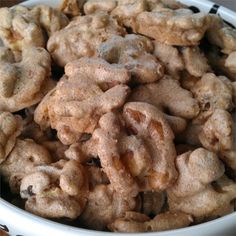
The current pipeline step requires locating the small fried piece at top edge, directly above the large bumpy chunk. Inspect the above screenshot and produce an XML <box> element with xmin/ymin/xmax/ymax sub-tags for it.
<box><xmin>84</xmin><ymin>0</ymin><xmax>117</xmax><ymax>15</ymax></box>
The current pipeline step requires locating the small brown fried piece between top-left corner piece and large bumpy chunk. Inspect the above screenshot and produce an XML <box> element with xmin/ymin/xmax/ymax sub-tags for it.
<box><xmin>31</xmin><ymin>5</ymin><xmax>69</xmax><ymax>36</ymax></box>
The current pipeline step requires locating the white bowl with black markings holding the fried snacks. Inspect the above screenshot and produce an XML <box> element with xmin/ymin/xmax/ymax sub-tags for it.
<box><xmin>0</xmin><ymin>0</ymin><xmax>236</xmax><ymax>236</ymax></box>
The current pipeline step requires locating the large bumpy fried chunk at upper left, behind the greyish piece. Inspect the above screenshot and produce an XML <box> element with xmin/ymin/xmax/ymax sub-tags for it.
<box><xmin>47</xmin><ymin>13</ymin><xmax>126</xmax><ymax>66</ymax></box>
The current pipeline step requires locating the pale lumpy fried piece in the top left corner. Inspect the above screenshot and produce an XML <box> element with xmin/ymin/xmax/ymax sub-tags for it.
<box><xmin>0</xmin><ymin>6</ymin><xmax>45</xmax><ymax>51</ymax></box>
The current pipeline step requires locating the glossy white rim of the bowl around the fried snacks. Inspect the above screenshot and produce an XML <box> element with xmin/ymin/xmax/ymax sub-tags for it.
<box><xmin>0</xmin><ymin>0</ymin><xmax>236</xmax><ymax>236</ymax></box>
